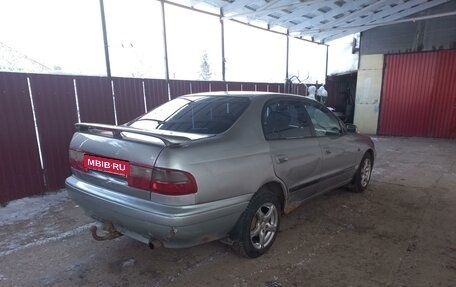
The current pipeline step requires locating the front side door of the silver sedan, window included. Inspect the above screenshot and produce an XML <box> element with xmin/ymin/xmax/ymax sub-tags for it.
<box><xmin>305</xmin><ymin>101</ymin><xmax>359</xmax><ymax>192</ymax></box>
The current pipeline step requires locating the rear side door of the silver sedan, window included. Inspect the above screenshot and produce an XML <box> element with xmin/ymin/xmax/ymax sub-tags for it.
<box><xmin>262</xmin><ymin>99</ymin><xmax>322</xmax><ymax>201</ymax></box>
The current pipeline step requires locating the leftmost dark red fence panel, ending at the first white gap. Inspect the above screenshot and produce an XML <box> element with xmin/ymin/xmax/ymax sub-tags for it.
<box><xmin>0</xmin><ymin>73</ymin><xmax>44</xmax><ymax>202</ymax></box>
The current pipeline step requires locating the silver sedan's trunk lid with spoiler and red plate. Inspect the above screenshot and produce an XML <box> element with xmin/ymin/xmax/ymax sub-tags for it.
<box><xmin>70</xmin><ymin>123</ymin><xmax>207</xmax><ymax>200</ymax></box>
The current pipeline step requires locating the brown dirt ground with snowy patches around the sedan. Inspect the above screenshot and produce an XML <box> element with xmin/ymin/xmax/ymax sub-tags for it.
<box><xmin>0</xmin><ymin>137</ymin><xmax>456</xmax><ymax>287</ymax></box>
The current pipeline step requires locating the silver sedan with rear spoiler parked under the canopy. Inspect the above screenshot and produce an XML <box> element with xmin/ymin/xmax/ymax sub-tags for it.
<box><xmin>66</xmin><ymin>92</ymin><xmax>375</xmax><ymax>258</ymax></box>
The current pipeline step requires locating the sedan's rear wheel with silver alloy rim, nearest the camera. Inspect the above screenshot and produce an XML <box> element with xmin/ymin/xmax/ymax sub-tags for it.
<box><xmin>231</xmin><ymin>188</ymin><xmax>281</xmax><ymax>258</ymax></box>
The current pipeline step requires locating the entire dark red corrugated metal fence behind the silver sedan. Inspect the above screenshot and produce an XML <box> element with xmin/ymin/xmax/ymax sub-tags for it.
<box><xmin>0</xmin><ymin>72</ymin><xmax>306</xmax><ymax>202</ymax></box>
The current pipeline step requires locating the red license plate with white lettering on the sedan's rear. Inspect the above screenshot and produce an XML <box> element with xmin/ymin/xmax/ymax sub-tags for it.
<box><xmin>84</xmin><ymin>154</ymin><xmax>130</xmax><ymax>176</ymax></box>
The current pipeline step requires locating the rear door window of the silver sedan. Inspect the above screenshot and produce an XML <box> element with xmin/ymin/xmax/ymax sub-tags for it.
<box><xmin>262</xmin><ymin>100</ymin><xmax>312</xmax><ymax>140</ymax></box>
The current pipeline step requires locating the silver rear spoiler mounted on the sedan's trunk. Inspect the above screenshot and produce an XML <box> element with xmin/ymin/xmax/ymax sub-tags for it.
<box><xmin>75</xmin><ymin>123</ymin><xmax>190</xmax><ymax>146</ymax></box>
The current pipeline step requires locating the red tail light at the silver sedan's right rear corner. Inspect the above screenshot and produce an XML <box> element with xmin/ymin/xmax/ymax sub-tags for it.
<box><xmin>128</xmin><ymin>164</ymin><xmax>197</xmax><ymax>196</ymax></box>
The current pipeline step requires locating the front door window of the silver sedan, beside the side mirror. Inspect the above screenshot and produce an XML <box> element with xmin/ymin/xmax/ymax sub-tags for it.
<box><xmin>306</xmin><ymin>104</ymin><xmax>342</xmax><ymax>137</ymax></box>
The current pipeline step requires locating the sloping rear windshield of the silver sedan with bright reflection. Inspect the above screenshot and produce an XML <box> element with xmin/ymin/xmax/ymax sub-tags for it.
<box><xmin>130</xmin><ymin>96</ymin><xmax>250</xmax><ymax>134</ymax></box>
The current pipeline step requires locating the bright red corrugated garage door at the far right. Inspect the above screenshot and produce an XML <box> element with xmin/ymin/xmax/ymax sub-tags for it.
<box><xmin>379</xmin><ymin>50</ymin><xmax>456</xmax><ymax>138</ymax></box>
